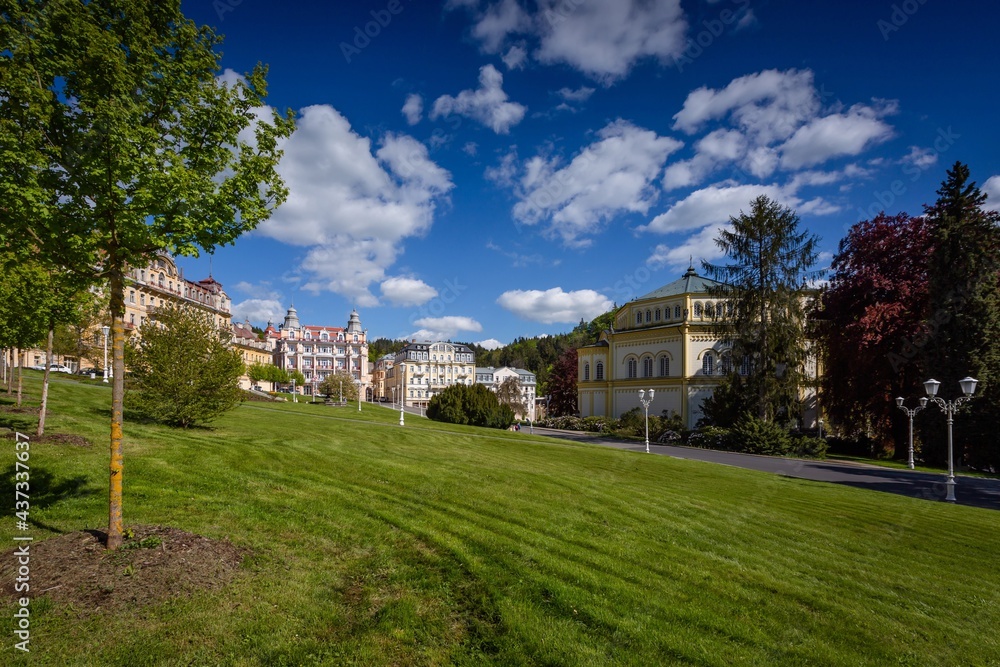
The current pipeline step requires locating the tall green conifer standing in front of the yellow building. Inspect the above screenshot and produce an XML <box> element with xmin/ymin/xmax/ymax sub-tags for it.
<box><xmin>702</xmin><ymin>195</ymin><xmax>818</xmax><ymax>421</ymax></box>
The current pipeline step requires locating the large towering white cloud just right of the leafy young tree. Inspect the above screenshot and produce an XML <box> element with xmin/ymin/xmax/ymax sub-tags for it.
<box><xmin>258</xmin><ymin>105</ymin><xmax>454</xmax><ymax>306</ymax></box>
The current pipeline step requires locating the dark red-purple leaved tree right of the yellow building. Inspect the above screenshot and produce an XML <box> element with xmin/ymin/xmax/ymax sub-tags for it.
<box><xmin>818</xmin><ymin>212</ymin><xmax>931</xmax><ymax>458</ymax></box>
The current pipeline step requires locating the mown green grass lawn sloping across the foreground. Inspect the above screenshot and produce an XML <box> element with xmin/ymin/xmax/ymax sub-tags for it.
<box><xmin>0</xmin><ymin>374</ymin><xmax>1000</xmax><ymax>666</ymax></box>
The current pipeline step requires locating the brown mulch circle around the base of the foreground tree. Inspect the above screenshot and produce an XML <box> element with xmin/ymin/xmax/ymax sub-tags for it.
<box><xmin>0</xmin><ymin>526</ymin><xmax>249</xmax><ymax>615</ymax></box>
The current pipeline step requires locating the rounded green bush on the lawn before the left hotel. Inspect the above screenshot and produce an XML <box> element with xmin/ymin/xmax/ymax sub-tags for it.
<box><xmin>125</xmin><ymin>306</ymin><xmax>244</xmax><ymax>427</ymax></box>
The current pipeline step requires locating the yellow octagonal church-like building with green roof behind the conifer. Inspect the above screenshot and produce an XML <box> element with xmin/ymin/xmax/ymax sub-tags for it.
<box><xmin>577</xmin><ymin>268</ymin><xmax>819</xmax><ymax>428</ymax></box>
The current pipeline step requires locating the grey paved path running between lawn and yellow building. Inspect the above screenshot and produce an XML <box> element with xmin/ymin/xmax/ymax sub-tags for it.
<box><xmin>534</xmin><ymin>428</ymin><xmax>1000</xmax><ymax>510</ymax></box>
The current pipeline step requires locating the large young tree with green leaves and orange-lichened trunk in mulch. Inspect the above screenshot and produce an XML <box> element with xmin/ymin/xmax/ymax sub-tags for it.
<box><xmin>0</xmin><ymin>0</ymin><xmax>293</xmax><ymax>549</ymax></box>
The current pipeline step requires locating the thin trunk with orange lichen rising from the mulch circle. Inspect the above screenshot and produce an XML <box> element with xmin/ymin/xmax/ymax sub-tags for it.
<box><xmin>107</xmin><ymin>271</ymin><xmax>125</xmax><ymax>551</ymax></box>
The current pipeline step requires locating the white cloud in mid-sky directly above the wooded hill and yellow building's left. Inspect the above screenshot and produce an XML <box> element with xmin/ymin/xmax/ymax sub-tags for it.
<box><xmin>508</xmin><ymin>120</ymin><xmax>682</xmax><ymax>246</ymax></box>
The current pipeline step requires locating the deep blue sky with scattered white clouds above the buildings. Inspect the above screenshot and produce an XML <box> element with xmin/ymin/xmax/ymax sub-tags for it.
<box><xmin>174</xmin><ymin>0</ymin><xmax>1000</xmax><ymax>345</ymax></box>
